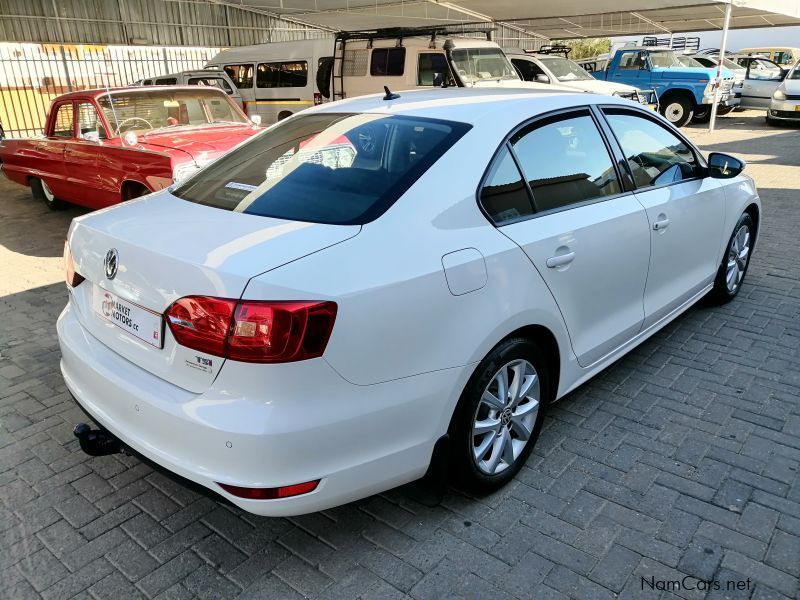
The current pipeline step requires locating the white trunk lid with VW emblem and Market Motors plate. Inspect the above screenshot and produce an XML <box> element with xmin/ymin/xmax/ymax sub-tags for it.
<box><xmin>69</xmin><ymin>191</ymin><xmax>361</xmax><ymax>393</ymax></box>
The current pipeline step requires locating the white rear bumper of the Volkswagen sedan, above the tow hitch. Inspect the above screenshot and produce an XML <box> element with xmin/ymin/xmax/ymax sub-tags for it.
<box><xmin>57</xmin><ymin>304</ymin><xmax>468</xmax><ymax>516</ymax></box>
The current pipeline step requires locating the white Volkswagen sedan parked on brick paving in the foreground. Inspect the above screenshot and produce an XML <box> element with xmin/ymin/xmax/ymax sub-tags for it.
<box><xmin>58</xmin><ymin>89</ymin><xmax>761</xmax><ymax>515</ymax></box>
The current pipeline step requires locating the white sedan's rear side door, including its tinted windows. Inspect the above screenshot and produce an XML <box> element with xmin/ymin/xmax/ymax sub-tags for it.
<box><xmin>488</xmin><ymin>108</ymin><xmax>650</xmax><ymax>366</ymax></box>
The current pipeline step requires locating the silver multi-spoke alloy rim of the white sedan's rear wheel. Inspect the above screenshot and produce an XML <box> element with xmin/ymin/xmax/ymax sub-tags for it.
<box><xmin>472</xmin><ymin>359</ymin><xmax>541</xmax><ymax>475</ymax></box>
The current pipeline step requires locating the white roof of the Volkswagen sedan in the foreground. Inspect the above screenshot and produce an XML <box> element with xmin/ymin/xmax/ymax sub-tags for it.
<box><xmin>312</xmin><ymin>84</ymin><xmax>630</xmax><ymax>126</ymax></box>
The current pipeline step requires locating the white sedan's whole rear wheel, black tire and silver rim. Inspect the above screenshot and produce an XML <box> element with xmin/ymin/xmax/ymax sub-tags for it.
<box><xmin>450</xmin><ymin>338</ymin><xmax>550</xmax><ymax>493</ymax></box>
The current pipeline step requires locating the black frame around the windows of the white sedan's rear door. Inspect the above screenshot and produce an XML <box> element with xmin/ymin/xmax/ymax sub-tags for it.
<box><xmin>475</xmin><ymin>104</ymin><xmax>633</xmax><ymax>228</ymax></box>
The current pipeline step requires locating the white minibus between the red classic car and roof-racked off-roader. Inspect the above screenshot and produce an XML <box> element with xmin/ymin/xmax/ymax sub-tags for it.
<box><xmin>206</xmin><ymin>38</ymin><xmax>334</xmax><ymax>125</ymax></box>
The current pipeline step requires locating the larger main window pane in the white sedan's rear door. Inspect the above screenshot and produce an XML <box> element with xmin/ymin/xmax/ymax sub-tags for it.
<box><xmin>512</xmin><ymin>111</ymin><xmax>621</xmax><ymax>212</ymax></box>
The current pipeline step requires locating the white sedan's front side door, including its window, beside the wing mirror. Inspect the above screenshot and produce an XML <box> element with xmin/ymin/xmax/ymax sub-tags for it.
<box><xmin>603</xmin><ymin>107</ymin><xmax>725</xmax><ymax>328</ymax></box>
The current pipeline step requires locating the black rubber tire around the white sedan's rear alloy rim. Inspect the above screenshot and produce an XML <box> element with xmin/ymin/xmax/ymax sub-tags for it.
<box><xmin>449</xmin><ymin>338</ymin><xmax>551</xmax><ymax>493</ymax></box>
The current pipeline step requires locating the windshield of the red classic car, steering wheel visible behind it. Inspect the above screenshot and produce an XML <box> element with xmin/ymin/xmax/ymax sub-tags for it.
<box><xmin>97</xmin><ymin>87</ymin><xmax>247</xmax><ymax>135</ymax></box>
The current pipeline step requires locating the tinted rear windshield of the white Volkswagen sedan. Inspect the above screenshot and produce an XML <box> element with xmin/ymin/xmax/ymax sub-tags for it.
<box><xmin>173</xmin><ymin>113</ymin><xmax>470</xmax><ymax>225</ymax></box>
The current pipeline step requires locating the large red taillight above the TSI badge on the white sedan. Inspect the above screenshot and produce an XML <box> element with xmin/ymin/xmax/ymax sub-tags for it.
<box><xmin>166</xmin><ymin>296</ymin><xmax>336</xmax><ymax>363</ymax></box>
